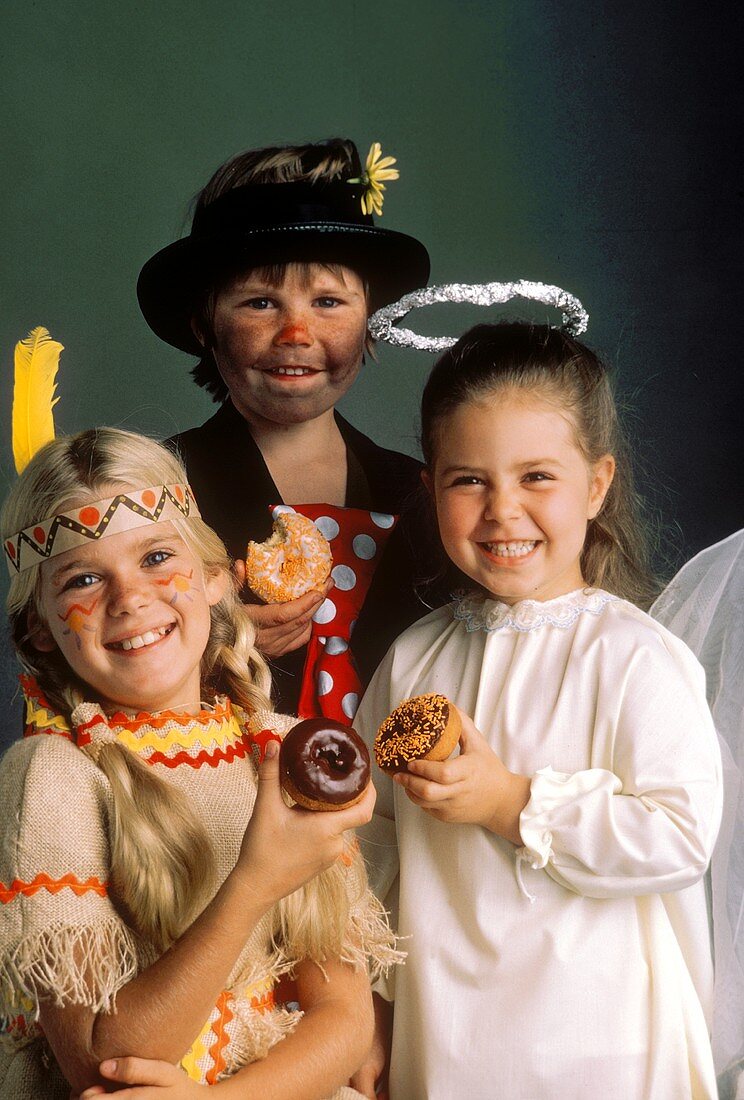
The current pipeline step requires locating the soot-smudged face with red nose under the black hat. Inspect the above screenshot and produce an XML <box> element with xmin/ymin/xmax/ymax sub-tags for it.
<box><xmin>203</xmin><ymin>264</ymin><xmax>366</xmax><ymax>425</ymax></box>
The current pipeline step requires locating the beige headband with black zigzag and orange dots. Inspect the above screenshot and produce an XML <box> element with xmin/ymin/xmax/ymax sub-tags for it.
<box><xmin>4</xmin><ymin>483</ymin><xmax>200</xmax><ymax>576</ymax></box>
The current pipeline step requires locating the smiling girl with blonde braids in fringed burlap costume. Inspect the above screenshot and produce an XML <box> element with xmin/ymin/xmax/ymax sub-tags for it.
<box><xmin>0</xmin><ymin>429</ymin><xmax>393</xmax><ymax>1100</ymax></box>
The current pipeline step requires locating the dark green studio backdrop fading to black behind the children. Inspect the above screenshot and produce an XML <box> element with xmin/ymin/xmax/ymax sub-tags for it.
<box><xmin>0</xmin><ymin>0</ymin><xmax>744</xmax><ymax>743</ymax></box>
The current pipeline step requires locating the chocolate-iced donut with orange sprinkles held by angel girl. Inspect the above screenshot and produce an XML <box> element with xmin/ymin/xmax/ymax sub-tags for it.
<box><xmin>374</xmin><ymin>694</ymin><xmax>461</xmax><ymax>771</ymax></box>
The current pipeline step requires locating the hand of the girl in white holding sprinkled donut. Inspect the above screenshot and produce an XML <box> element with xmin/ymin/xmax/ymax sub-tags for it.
<box><xmin>393</xmin><ymin>711</ymin><xmax>530</xmax><ymax>845</ymax></box>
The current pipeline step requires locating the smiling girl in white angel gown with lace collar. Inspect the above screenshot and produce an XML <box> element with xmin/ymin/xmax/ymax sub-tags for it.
<box><xmin>355</xmin><ymin>323</ymin><xmax>721</xmax><ymax>1100</ymax></box>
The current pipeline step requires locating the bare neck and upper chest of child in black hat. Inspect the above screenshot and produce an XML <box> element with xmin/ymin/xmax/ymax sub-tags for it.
<box><xmin>245</xmin><ymin>409</ymin><xmax>347</xmax><ymax>506</ymax></box>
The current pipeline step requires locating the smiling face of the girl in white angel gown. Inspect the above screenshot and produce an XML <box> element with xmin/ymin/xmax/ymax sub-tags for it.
<box><xmin>425</xmin><ymin>393</ymin><xmax>614</xmax><ymax>604</ymax></box>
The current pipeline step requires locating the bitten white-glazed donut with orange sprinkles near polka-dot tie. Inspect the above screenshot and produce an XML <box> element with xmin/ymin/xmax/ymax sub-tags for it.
<box><xmin>245</xmin><ymin>512</ymin><xmax>333</xmax><ymax>604</ymax></box>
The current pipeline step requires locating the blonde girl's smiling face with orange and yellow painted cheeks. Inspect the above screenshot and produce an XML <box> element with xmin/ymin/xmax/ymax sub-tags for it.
<box><xmin>34</xmin><ymin>523</ymin><xmax>228</xmax><ymax>711</ymax></box>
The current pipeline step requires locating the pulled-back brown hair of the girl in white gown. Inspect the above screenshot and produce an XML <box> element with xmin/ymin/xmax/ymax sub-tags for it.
<box><xmin>422</xmin><ymin>322</ymin><xmax>659</xmax><ymax>608</ymax></box>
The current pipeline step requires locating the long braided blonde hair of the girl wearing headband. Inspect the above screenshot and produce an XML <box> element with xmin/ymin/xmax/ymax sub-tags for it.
<box><xmin>0</xmin><ymin>428</ymin><xmax>271</xmax><ymax>950</ymax></box>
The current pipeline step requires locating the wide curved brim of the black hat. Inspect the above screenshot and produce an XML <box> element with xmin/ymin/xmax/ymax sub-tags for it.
<box><xmin>136</xmin><ymin>222</ymin><xmax>430</xmax><ymax>355</ymax></box>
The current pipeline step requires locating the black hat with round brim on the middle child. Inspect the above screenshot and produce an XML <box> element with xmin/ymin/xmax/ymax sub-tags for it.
<box><xmin>136</xmin><ymin>182</ymin><xmax>429</xmax><ymax>355</ymax></box>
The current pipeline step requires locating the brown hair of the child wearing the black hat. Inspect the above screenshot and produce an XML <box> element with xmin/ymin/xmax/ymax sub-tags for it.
<box><xmin>192</xmin><ymin>138</ymin><xmax>372</xmax><ymax>403</ymax></box>
